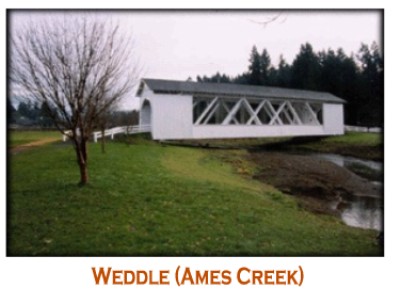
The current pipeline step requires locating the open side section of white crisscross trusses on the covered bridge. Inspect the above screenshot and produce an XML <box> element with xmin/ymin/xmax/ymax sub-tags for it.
<box><xmin>193</xmin><ymin>96</ymin><xmax>322</xmax><ymax>126</ymax></box>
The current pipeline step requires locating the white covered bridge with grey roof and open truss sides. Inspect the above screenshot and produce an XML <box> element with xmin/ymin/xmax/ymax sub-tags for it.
<box><xmin>137</xmin><ymin>79</ymin><xmax>345</xmax><ymax>140</ymax></box>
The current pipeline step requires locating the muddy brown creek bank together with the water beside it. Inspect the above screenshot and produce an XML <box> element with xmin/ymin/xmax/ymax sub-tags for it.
<box><xmin>250</xmin><ymin>151</ymin><xmax>383</xmax><ymax>230</ymax></box>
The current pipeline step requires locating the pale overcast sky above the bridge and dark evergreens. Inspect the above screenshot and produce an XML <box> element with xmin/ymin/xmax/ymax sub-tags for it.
<box><xmin>10</xmin><ymin>10</ymin><xmax>382</xmax><ymax>108</ymax></box>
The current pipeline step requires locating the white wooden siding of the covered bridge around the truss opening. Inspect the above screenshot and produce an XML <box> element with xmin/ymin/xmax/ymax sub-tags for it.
<box><xmin>140</xmin><ymin>86</ymin><xmax>344</xmax><ymax>140</ymax></box>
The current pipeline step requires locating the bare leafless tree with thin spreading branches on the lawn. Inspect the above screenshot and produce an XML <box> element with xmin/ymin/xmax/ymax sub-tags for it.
<box><xmin>10</xmin><ymin>13</ymin><xmax>137</xmax><ymax>185</ymax></box>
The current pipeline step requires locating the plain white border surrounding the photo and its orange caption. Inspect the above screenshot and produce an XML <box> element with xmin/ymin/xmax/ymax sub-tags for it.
<box><xmin>0</xmin><ymin>0</ymin><xmax>400</xmax><ymax>300</ymax></box>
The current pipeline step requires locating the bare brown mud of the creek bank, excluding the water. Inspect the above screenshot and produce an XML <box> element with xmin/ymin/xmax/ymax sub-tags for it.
<box><xmin>250</xmin><ymin>151</ymin><xmax>382</xmax><ymax>214</ymax></box>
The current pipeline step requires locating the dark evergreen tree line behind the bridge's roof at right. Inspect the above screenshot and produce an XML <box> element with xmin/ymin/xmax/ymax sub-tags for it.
<box><xmin>197</xmin><ymin>42</ymin><xmax>384</xmax><ymax>126</ymax></box>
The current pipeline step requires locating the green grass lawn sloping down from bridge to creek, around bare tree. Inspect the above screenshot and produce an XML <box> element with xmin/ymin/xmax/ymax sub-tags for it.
<box><xmin>7</xmin><ymin>133</ymin><xmax>382</xmax><ymax>256</ymax></box>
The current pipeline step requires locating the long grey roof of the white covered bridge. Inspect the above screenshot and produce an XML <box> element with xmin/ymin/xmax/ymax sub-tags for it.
<box><xmin>137</xmin><ymin>79</ymin><xmax>346</xmax><ymax>103</ymax></box>
